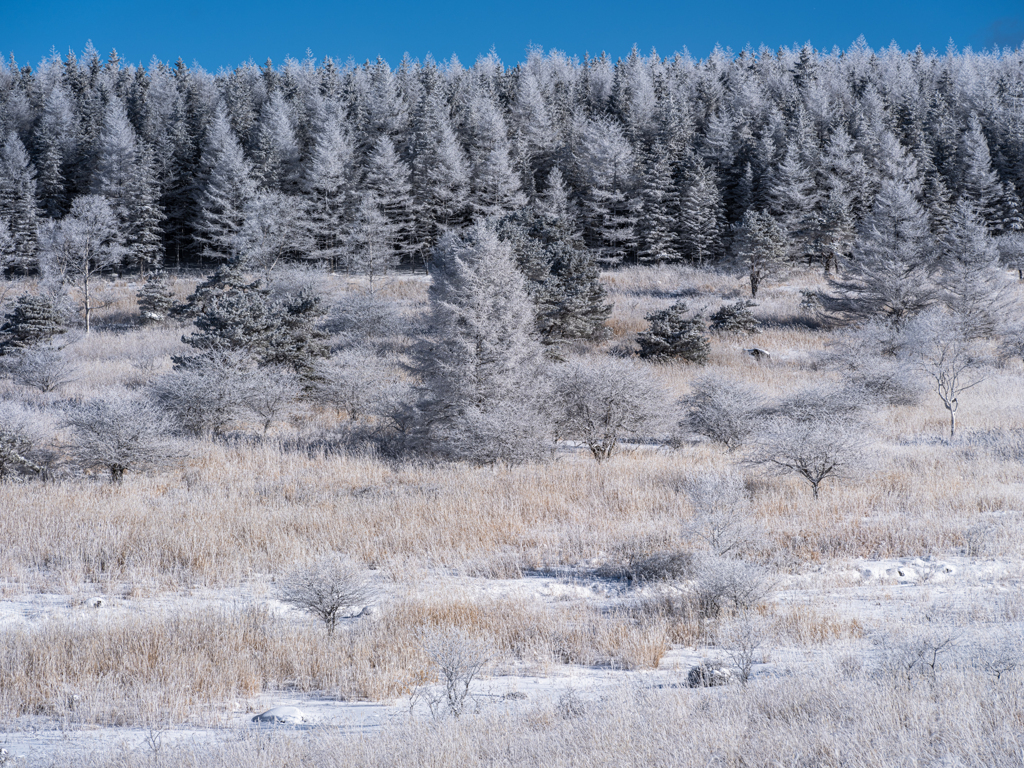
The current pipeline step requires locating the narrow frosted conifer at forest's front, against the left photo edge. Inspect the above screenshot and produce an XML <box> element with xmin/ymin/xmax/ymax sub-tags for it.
<box><xmin>0</xmin><ymin>131</ymin><xmax>39</xmax><ymax>270</ymax></box>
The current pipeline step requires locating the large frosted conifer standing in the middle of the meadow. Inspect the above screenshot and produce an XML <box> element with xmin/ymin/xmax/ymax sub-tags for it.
<box><xmin>413</xmin><ymin>224</ymin><xmax>545</xmax><ymax>464</ymax></box>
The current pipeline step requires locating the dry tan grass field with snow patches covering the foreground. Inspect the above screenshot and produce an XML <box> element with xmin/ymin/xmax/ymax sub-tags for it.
<box><xmin>0</xmin><ymin>267</ymin><xmax>1024</xmax><ymax>768</ymax></box>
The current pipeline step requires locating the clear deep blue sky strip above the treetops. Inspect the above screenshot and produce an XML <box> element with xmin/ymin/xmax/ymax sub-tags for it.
<box><xmin>0</xmin><ymin>0</ymin><xmax>1024</xmax><ymax>72</ymax></box>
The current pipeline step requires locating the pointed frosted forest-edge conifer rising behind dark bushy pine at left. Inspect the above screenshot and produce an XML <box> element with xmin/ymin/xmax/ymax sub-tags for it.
<box><xmin>197</xmin><ymin>105</ymin><xmax>256</xmax><ymax>259</ymax></box>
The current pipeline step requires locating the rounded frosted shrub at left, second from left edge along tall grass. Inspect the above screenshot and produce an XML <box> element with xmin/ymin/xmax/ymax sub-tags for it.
<box><xmin>63</xmin><ymin>399</ymin><xmax>175</xmax><ymax>482</ymax></box>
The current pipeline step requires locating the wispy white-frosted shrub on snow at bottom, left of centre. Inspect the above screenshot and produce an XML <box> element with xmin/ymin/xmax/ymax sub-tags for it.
<box><xmin>414</xmin><ymin>627</ymin><xmax>494</xmax><ymax>718</ymax></box>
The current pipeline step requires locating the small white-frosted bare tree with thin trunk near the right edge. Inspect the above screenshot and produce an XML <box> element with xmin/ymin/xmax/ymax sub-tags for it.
<box><xmin>903</xmin><ymin>309</ymin><xmax>985</xmax><ymax>440</ymax></box>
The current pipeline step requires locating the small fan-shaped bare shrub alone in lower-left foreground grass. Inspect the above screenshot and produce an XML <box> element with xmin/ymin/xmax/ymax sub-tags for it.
<box><xmin>278</xmin><ymin>553</ymin><xmax>380</xmax><ymax>635</ymax></box>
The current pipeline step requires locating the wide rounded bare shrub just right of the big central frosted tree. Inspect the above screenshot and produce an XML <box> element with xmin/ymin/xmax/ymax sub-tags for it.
<box><xmin>553</xmin><ymin>359</ymin><xmax>669</xmax><ymax>461</ymax></box>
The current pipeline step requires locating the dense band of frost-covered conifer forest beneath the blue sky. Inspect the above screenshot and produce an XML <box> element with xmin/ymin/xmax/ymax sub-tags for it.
<box><xmin>0</xmin><ymin>43</ymin><xmax>1024</xmax><ymax>270</ymax></box>
